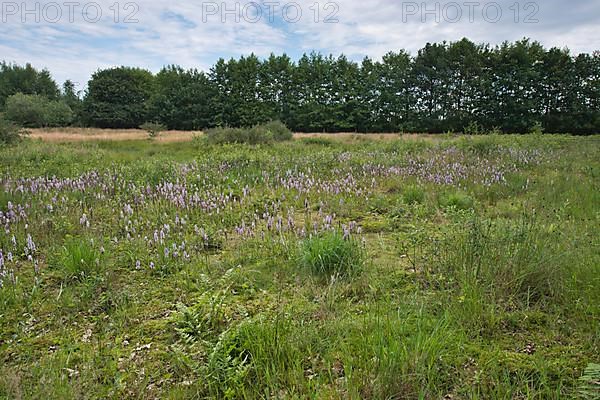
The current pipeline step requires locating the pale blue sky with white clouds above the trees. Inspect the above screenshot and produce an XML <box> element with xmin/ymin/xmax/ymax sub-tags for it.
<box><xmin>0</xmin><ymin>0</ymin><xmax>600</xmax><ymax>89</ymax></box>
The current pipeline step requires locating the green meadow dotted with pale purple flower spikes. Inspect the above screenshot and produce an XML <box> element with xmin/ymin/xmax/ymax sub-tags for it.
<box><xmin>0</xmin><ymin>135</ymin><xmax>600</xmax><ymax>399</ymax></box>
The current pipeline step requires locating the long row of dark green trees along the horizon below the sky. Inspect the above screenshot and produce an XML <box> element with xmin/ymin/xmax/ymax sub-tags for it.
<box><xmin>0</xmin><ymin>39</ymin><xmax>600</xmax><ymax>134</ymax></box>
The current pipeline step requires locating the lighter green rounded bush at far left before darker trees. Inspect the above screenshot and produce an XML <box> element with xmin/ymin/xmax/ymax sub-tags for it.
<box><xmin>5</xmin><ymin>93</ymin><xmax>73</xmax><ymax>128</ymax></box>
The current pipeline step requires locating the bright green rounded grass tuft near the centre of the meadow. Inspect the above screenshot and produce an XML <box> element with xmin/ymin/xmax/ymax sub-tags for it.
<box><xmin>300</xmin><ymin>231</ymin><xmax>364</xmax><ymax>278</ymax></box>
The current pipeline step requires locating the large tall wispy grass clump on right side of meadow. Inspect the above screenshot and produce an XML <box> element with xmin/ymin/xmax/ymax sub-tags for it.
<box><xmin>444</xmin><ymin>216</ymin><xmax>569</xmax><ymax>306</ymax></box>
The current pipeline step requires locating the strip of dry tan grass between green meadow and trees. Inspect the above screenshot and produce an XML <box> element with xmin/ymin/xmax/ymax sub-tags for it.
<box><xmin>29</xmin><ymin>128</ymin><xmax>431</xmax><ymax>143</ymax></box>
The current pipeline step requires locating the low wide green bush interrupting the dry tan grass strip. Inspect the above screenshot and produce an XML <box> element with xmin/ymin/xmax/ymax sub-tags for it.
<box><xmin>206</xmin><ymin>121</ymin><xmax>293</xmax><ymax>145</ymax></box>
